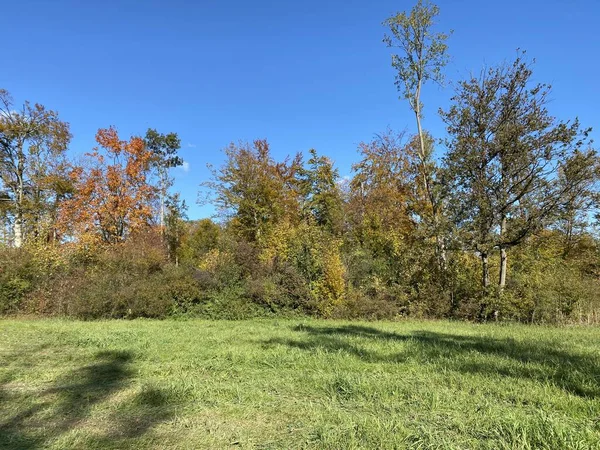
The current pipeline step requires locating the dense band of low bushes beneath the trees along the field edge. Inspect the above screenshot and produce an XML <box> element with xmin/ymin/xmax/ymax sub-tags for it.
<box><xmin>0</xmin><ymin>229</ymin><xmax>600</xmax><ymax>323</ymax></box>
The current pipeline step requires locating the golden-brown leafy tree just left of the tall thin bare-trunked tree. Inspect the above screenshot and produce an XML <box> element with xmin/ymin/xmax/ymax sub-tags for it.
<box><xmin>344</xmin><ymin>130</ymin><xmax>428</xmax><ymax>298</ymax></box>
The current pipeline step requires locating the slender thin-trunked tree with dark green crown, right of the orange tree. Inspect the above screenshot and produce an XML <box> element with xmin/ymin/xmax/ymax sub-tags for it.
<box><xmin>144</xmin><ymin>128</ymin><xmax>183</xmax><ymax>237</ymax></box>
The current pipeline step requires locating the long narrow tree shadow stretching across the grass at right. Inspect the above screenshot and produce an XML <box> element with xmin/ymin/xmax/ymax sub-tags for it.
<box><xmin>266</xmin><ymin>325</ymin><xmax>600</xmax><ymax>398</ymax></box>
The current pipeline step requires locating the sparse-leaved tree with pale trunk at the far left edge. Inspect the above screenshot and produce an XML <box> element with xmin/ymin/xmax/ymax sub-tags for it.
<box><xmin>0</xmin><ymin>89</ymin><xmax>71</xmax><ymax>247</ymax></box>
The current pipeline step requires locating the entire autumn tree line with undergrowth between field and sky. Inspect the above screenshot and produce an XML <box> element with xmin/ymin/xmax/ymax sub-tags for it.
<box><xmin>0</xmin><ymin>1</ymin><xmax>600</xmax><ymax>322</ymax></box>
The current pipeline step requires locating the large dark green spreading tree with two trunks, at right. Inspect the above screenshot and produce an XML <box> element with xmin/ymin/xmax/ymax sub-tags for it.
<box><xmin>442</xmin><ymin>54</ymin><xmax>589</xmax><ymax>292</ymax></box>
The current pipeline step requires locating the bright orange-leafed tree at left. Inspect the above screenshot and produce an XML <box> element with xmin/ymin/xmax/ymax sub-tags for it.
<box><xmin>62</xmin><ymin>127</ymin><xmax>157</xmax><ymax>243</ymax></box>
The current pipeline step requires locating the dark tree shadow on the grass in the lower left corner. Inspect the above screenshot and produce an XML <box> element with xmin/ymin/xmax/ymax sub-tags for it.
<box><xmin>0</xmin><ymin>351</ymin><xmax>171</xmax><ymax>449</ymax></box>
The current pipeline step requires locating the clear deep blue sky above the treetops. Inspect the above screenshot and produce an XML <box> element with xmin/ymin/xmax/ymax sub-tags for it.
<box><xmin>0</xmin><ymin>0</ymin><xmax>600</xmax><ymax>218</ymax></box>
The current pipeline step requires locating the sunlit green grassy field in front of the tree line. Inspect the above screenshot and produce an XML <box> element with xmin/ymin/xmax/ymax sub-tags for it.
<box><xmin>0</xmin><ymin>320</ymin><xmax>600</xmax><ymax>449</ymax></box>
